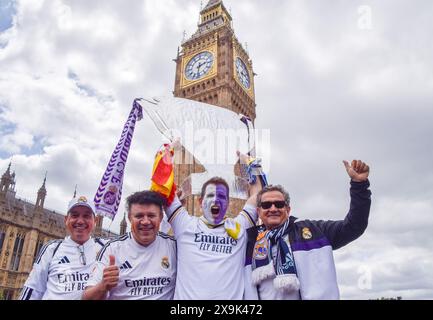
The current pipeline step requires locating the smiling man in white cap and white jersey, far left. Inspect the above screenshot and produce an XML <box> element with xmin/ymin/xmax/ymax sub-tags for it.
<box><xmin>20</xmin><ymin>196</ymin><xmax>104</xmax><ymax>300</ymax></box>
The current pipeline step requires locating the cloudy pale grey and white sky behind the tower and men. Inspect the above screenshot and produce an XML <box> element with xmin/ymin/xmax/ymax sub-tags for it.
<box><xmin>0</xmin><ymin>0</ymin><xmax>433</xmax><ymax>299</ymax></box>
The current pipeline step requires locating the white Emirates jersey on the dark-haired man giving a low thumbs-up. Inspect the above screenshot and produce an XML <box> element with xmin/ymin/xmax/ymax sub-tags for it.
<box><xmin>88</xmin><ymin>232</ymin><xmax>176</xmax><ymax>300</ymax></box>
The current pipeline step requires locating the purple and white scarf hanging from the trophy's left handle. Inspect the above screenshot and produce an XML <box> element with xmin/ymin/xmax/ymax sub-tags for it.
<box><xmin>93</xmin><ymin>99</ymin><xmax>143</xmax><ymax>220</ymax></box>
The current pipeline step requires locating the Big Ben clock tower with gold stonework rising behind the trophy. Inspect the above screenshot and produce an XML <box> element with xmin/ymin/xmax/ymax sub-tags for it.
<box><xmin>173</xmin><ymin>0</ymin><xmax>256</xmax><ymax>215</ymax></box>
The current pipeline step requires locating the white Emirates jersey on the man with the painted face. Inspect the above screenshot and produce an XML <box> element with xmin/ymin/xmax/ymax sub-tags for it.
<box><xmin>166</xmin><ymin>198</ymin><xmax>257</xmax><ymax>300</ymax></box>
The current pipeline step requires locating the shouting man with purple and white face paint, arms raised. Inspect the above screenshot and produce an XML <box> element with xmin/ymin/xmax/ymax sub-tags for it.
<box><xmin>165</xmin><ymin>155</ymin><xmax>262</xmax><ymax>300</ymax></box>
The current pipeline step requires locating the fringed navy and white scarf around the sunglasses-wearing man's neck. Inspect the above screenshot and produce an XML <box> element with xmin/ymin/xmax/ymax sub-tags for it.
<box><xmin>252</xmin><ymin>220</ymin><xmax>300</xmax><ymax>292</ymax></box>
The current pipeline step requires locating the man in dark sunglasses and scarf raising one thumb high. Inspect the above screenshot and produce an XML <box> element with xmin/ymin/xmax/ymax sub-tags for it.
<box><xmin>246</xmin><ymin>160</ymin><xmax>371</xmax><ymax>300</ymax></box>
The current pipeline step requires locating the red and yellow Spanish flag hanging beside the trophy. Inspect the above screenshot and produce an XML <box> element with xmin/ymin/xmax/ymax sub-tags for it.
<box><xmin>150</xmin><ymin>144</ymin><xmax>176</xmax><ymax>205</ymax></box>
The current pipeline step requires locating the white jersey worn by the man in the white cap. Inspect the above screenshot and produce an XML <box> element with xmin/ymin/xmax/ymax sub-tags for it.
<box><xmin>20</xmin><ymin>237</ymin><xmax>106</xmax><ymax>300</ymax></box>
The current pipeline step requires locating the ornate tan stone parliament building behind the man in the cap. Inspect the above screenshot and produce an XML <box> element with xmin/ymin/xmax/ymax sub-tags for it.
<box><xmin>0</xmin><ymin>164</ymin><xmax>123</xmax><ymax>300</ymax></box>
